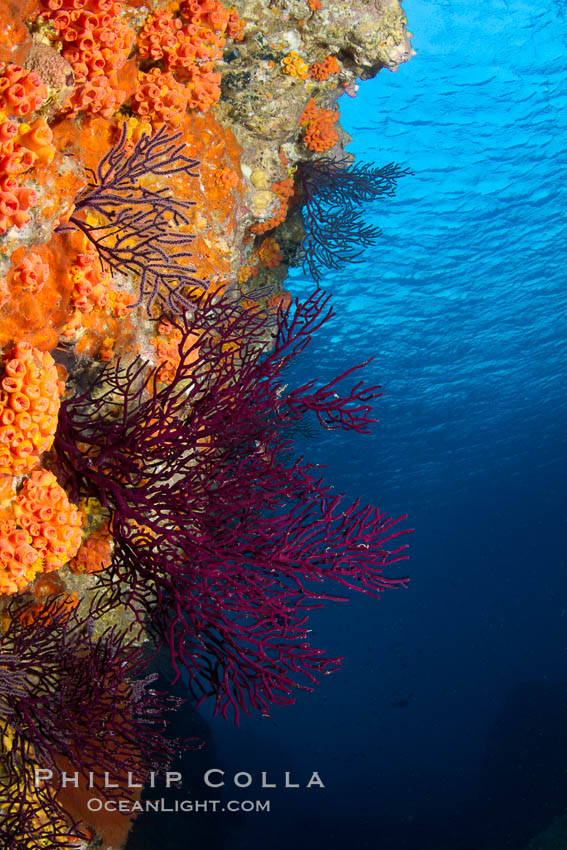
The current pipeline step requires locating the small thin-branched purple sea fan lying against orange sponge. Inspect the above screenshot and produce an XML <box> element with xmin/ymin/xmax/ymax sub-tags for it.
<box><xmin>60</xmin><ymin>124</ymin><xmax>206</xmax><ymax>316</ymax></box>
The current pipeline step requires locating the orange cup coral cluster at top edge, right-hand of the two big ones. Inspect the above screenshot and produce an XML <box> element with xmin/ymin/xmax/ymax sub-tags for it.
<box><xmin>134</xmin><ymin>0</ymin><xmax>244</xmax><ymax>123</ymax></box>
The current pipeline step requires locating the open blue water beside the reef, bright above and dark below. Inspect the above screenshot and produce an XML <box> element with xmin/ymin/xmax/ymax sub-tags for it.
<box><xmin>126</xmin><ymin>0</ymin><xmax>567</xmax><ymax>850</ymax></box>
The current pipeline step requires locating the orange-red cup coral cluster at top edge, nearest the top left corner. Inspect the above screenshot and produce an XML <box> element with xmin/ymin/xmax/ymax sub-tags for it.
<box><xmin>37</xmin><ymin>0</ymin><xmax>134</xmax><ymax>118</ymax></box>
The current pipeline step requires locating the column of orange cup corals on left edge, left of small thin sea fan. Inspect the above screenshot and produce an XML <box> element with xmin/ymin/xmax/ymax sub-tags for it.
<box><xmin>0</xmin><ymin>64</ymin><xmax>54</xmax><ymax>234</ymax></box>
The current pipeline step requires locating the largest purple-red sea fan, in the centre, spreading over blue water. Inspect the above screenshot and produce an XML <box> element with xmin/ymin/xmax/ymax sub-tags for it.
<box><xmin>54</xmin><ymin>290</ymin><xmax>407</xmax><ymax>721</ymax></box>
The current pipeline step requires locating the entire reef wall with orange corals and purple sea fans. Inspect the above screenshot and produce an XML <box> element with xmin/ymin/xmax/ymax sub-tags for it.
<box><xmin>0</xmin><ymin>0</ymin><xmax>418</xmax><ymax>850</ymax></box>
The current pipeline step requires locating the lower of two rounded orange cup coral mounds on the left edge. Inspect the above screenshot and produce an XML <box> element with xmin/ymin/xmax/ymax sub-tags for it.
<box><xmin>0</xmin><ymin>470</ymin><xmax>82</xmax><ymax>594</ymax></box>
